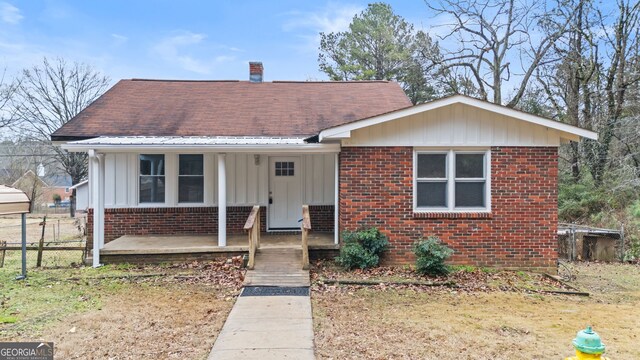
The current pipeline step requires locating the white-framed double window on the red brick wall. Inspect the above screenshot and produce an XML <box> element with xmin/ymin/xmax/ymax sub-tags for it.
<box><xmin>414</xmin><ymin>150</ymin><xmax>489</xmax><ymax>211</ymax></box>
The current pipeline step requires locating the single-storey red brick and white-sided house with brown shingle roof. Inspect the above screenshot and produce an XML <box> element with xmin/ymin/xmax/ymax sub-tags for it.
<box><xmin>52</xmin><ymin>63</ymin><xmax>597</xmax><ymax>270</ymax></box>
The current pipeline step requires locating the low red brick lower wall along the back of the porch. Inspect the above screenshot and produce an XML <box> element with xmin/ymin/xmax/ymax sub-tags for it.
<box><xmin>87</xmin><ymin>205</ymin><xmax>334</xmax><ymax>248</ymax></box>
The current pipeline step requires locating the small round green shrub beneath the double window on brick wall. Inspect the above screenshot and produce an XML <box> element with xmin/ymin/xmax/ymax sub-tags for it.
<box><xmin>413</xmin><ymin>236</ymin><xmax>453</xmax><ymax>276</ymax></box>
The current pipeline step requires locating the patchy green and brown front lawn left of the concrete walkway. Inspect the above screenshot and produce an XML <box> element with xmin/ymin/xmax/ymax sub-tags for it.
<box><xmin>0</xmin><ymin>262</ymin><xmax>243</xmax><ymax>359</ymax></box>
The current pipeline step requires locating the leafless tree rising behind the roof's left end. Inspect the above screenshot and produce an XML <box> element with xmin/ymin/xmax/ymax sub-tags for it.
<box><xmin>13</xmin><ymin>58</ymin><xmax>110</xmax><ymax>216</ymax></box>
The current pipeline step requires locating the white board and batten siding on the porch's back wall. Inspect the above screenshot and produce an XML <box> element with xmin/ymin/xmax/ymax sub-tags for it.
<box><xmin>97</xmin><ymin>153</ymin><xmax>335</xmax><ymax>208</ymax></box>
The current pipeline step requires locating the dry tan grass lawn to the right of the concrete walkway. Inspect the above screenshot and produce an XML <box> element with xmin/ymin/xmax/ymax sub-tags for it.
<box><xmin>313</xmin><ymin>264</ymin><xmax>640</xmax><ymax>360</ymax></box>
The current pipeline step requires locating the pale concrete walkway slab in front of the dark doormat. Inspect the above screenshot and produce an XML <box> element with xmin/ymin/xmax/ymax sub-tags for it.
<box><xmin>209</xmin><ymin>296</ymin><xmax>315</xmax><ymax>360</ymax></box>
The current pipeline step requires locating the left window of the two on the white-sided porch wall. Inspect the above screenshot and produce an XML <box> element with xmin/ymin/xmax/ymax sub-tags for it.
<box><xmin>139</xmin><ymin>155</ymin><xmax>165</xmax><ymax>203</ymax></box>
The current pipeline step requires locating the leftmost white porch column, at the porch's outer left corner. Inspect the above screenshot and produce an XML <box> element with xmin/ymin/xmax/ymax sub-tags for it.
<box><xmin>89</xmin><ymin>150</ymin><xmax>104</xmax><ymax>267</ymax></box>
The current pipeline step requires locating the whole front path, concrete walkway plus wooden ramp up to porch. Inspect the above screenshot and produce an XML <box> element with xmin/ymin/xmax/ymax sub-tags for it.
<box><xmin>209</xmin><ymin>248</ymin><xmax>315</xmax><ymax>360</ymax></box>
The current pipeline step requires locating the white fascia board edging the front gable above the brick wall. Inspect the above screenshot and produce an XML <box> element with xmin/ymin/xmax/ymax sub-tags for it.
<box><xmin>319</xmin><ymin>95</ymin><xmax>598</xmax><ymax>141</ymax></box>
